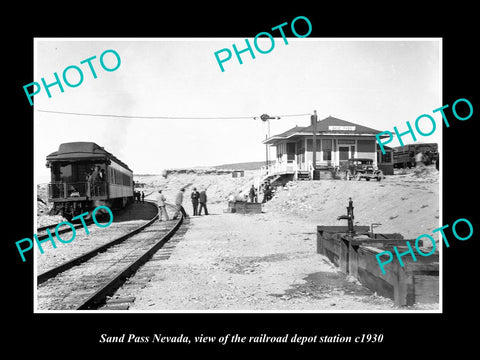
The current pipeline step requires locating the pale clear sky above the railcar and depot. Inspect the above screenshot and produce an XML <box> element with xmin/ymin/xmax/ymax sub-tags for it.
<box><xmin>32</xmin><ymin>37</ymin><xmax>443</xmax><ymax>183</ymax></box>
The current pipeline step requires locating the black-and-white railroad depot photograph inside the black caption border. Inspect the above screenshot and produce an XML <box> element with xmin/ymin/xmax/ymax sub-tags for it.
<box><xmin>32</xmin><ymin>36</ymin><xmax>442</xmax><ymax>312</ymax></box>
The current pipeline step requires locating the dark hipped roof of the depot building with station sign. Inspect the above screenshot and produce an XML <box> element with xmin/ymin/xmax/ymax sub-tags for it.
<box><xmin>263</xmin><ymin>116</ymin><xmax>381</xmax><ymax>144</ymax></box>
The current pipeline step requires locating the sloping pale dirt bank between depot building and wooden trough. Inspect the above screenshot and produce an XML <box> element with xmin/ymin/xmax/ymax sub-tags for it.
<box><xmin>264</xmin><ymin>166</ymin><xmax>441</xmax><ymax>238</ymax></box>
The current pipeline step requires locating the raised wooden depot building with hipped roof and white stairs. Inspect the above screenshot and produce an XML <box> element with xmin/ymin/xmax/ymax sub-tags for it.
<box><xmin>262</xmin><ymin>116</ymin><xmax>393</xmax><ymax>179</ymax></box>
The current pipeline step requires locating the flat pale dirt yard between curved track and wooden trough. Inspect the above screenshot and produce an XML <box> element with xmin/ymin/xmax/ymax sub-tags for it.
<box><xmin>127</xmin><ymin>204</ymin><xmax>393</xmax><ymax>311</ymax></box>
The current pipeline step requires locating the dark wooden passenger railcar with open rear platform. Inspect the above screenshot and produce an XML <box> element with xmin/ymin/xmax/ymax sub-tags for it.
<box><xmin>47</xmin><ymin>142</ymin><xmax>133</xmax><ymax>219</ymax></box>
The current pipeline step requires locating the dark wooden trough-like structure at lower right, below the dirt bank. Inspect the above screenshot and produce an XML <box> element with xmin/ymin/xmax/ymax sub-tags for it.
<box><xmin>317</xmin><ymin>226</ymin><xmax>439</xmax><ymax>306</ymax></box>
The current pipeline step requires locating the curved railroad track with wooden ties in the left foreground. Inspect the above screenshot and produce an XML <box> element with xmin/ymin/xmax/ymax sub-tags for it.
<box><xmin>37</xmin><ymin>202</ymin><xmax>183</xmax><ymax>310</ymax></box>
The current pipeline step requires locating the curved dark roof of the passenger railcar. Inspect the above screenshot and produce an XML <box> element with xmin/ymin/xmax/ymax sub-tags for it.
<box><xmin>47</xmin><ymin>141</ymin><xmax>132</xmax><ymax>171</ymax></box>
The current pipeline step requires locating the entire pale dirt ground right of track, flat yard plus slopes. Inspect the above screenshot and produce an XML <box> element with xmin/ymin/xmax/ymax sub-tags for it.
<box><xmin>37</xmin><ymin>167</ymin><xmax>440</xmax><ymax>312</ymax></box>
